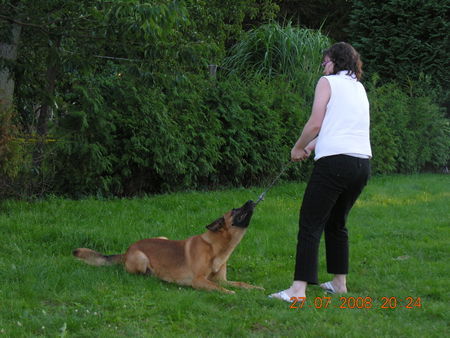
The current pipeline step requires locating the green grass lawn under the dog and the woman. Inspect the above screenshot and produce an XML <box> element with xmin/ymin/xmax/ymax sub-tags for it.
<box><xmin>0</xmin><ymin>175</ymin><xmax>450</xmax><ymax>337</ymax></box>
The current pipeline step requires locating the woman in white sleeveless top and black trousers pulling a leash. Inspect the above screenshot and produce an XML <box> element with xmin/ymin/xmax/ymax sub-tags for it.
<box><xmin>269</xmin><ymin>42</ymin><xmax>372</xmax><ymax>302</ymax></box>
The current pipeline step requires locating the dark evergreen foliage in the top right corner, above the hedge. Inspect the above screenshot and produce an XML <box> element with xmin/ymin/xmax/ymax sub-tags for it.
<box><xmin>348</xmin><ymin>0</ymin><xmax>450</xmax><ymax>100</ymax></box>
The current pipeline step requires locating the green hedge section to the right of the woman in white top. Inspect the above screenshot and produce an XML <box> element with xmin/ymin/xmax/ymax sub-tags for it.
<box><xmin>368</xmin><ymin>75</ymin><xmax>450</xmax><ymax>174</ymax></box>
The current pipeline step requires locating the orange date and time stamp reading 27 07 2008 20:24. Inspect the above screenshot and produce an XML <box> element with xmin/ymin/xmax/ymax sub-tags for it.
<box><xmin>289</xmin><ymin>297</ymin><xmax>422</xmax><ymax>309</ymax></box>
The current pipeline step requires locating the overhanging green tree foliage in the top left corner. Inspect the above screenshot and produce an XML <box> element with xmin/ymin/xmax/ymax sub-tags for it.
<box><xmin>0</xmin><ymin>0</ymin><xmax>186</xmax><ymax>131</ymax></box>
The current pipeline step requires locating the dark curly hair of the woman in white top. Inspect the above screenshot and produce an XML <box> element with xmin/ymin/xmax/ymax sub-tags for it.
<box><xmin>323</xmin><ymin>42</ymin><xmax>363</xmax><ymax>80</ymax></box>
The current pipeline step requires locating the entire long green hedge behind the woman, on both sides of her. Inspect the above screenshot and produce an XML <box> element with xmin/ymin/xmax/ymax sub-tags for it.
<box><xmin>44</xmin><ymin>71</ymin><xmax>450</xmax><ymax>196</ymax></box>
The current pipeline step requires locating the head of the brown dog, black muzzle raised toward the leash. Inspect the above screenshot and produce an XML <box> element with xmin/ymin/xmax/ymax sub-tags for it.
<box><xmin>206</xmin><ymin>200</ymin><xmax>256</xmax><ymax>232</ymax></box>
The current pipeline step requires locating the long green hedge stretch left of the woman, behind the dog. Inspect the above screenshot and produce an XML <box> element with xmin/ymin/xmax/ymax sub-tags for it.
<box><xmin>48</xmin><ymin>74</ymin><xmax>309</xmax><ymax>196</ymax></box>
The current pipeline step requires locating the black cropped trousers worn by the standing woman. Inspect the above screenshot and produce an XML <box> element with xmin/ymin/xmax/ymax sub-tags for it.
<box><xmin>294</xmin><ymin>155</ymin><xmax>370</xmax><ymax>284</ymax></box>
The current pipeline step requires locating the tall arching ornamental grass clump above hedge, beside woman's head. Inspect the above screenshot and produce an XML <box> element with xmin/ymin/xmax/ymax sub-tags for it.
<box><xmin>223</xmin><ymin>23</ymin><xmax>330</xmax><ymax>98</ymax></box>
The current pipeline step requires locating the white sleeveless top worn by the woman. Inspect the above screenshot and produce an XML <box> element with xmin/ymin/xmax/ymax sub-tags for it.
<box><xmin>314</xmin><ymin>70</ymin><xmax>372</xmax><ymax>161</ymax></box>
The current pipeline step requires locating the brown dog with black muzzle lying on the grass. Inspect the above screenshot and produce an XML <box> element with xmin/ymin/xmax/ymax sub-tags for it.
<box><xmin>73</xmin><ymin>201</ymin><xmax>263</xmax><ymax>293</ymax></box>
